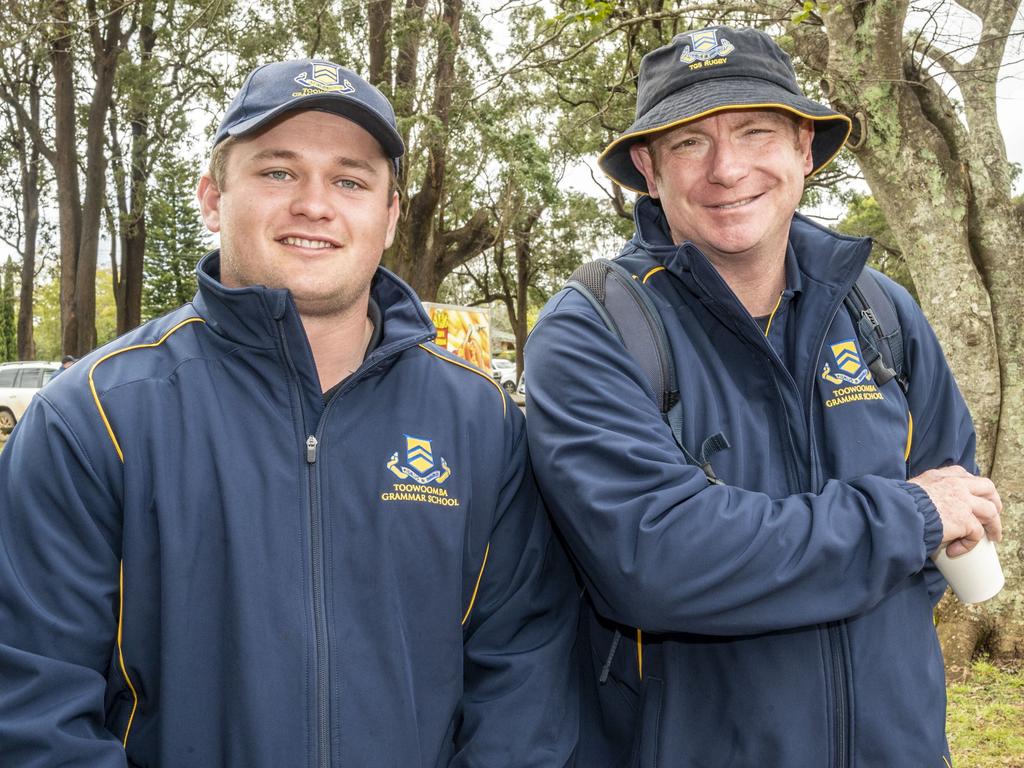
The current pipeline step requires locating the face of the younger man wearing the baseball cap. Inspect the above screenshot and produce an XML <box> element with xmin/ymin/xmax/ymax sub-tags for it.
<box><xmin>199</xmin><ymin>111</ymin><xmax>398</xmax><ymax>317</ymax></box>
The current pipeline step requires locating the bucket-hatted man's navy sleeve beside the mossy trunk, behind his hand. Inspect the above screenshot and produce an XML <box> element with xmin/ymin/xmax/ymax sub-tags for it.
<box><xmin>881</xmin><ymin>275</ymin><xmax>979</xmax><ymax>602</ymax></box>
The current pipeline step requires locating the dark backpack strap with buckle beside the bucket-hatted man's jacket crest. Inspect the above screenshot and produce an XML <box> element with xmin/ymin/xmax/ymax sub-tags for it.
<box><xmin>844</xmin><ymin>269</ymin><xmax>908</xmax><ymax>393</ymax></box>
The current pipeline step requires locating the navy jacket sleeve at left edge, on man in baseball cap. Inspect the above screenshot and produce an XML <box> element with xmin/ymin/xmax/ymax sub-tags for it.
<box><xmin>0</xmin><ymin>393</ymin><xmax>126</xmax><ymax>768</ymax></box>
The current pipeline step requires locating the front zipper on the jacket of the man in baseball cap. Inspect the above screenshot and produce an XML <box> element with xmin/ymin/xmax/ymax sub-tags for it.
<box><xmin>278</xmin><ymin>321</ymin><xmax>331</xmax><ymax>768</ymax></box>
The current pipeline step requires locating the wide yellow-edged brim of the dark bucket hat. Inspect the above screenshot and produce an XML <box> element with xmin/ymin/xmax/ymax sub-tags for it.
<box><xmin>597</xmin><ymin>77</ymin><xmax>853</xmax><ymax>195</ymax></box>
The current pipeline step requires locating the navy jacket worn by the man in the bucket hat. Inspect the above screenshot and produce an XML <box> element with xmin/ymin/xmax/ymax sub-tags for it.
<box><xmin>526</xmin><ymin>199</ymin><xmax>974</xmax><ymax>768</ymax></box>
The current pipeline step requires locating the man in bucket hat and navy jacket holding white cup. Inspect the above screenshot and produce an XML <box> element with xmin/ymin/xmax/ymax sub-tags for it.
<box><xmin>527</xmin><ymin>27</ymin><xmax>1000</xmax><ymax>768</ymax></box>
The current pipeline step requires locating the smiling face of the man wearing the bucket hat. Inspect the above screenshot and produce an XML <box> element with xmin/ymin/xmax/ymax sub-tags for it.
<box><xmin>631</xmin><ymin>110</ymin><xmax>813</xmax><ymax>264</ymax></box>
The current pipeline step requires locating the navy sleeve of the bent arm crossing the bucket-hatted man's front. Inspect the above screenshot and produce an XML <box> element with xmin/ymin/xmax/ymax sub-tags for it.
<box><xmin>526</xmin><ymin>292</ymin><xmax>941</xmax><ymax>635</ymax></box>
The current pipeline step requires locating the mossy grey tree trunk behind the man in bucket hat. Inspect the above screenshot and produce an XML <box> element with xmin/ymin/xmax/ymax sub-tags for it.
<box><xmin>791</xmin><ymin>0</ymin><xmax>1024</xmax><ymax>674</ymax></box>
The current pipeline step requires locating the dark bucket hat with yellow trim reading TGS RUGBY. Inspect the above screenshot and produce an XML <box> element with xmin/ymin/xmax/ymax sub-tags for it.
<box><xmin>597</xmin><ymin>27</ymin><xmax>852</xmax><ymax>193</ymax></box>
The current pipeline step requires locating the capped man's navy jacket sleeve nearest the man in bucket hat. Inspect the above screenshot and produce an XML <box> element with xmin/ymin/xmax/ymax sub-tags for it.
<box><xmin>450</xmin><ymin>415</ymin><xmax>579</xmax><ymax>768</ymax></box>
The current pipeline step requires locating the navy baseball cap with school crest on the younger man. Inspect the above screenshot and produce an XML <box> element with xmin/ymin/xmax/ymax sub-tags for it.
<box><xmin>213</xmin><ymin>58</ymin><xmax>406</xmax><ymax>170</ymax></box>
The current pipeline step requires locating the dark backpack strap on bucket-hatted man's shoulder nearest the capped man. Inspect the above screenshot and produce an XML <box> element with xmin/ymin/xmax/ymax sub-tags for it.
<box><xmin>566</xmin><ymin>259</ymin><xmax>729</xmax><ymax>484</ymax></box>
